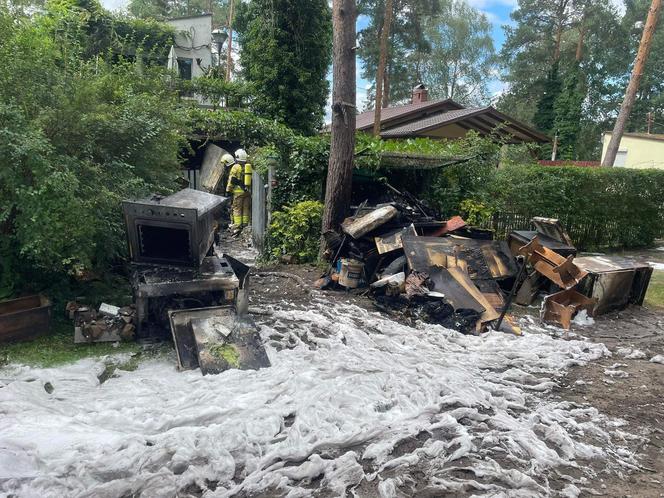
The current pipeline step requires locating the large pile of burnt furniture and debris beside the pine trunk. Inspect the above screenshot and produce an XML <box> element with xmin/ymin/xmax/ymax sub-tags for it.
<box><xmin>315</xmin><ymin>193</ymin><xmax>652</xmax><ymax>335</ymax></box>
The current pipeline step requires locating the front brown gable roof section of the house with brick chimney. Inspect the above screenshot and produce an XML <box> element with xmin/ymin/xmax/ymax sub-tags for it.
<box><xmin>381</xmin><ymin>106</ymin><xmax>549</xmax><ymax>142</ymax></box>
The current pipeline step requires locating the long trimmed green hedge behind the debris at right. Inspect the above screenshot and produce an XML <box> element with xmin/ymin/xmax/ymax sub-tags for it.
<box><xmin>474</xmin><ymin>165</ymin><xmax>664</xmax><ymax>250</ymax></box>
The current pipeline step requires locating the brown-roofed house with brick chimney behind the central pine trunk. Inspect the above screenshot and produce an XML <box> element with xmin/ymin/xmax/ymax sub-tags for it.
<box><xmin>355</xmin><ymin>84</ymin><xmax>549</xmax><ymax>143</ymax></box>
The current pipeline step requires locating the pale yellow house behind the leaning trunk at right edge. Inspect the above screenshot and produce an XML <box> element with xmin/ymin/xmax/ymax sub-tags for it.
<box><xmin>602</xmin><ymin>131</ymin><xmax>664</xmax><ymax>169</ymax></box>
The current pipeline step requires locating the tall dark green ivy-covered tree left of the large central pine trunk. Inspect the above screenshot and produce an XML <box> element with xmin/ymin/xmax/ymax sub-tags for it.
<box><xmin>237</xmin><ymin>0</ymin><xmax>332</xmax><ymax>134</ymax></box>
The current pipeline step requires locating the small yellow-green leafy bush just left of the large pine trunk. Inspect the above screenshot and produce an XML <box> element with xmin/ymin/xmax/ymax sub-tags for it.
<box><xmin>268</xmin><ymin>201</ymin><xmax>323</xmax><ymax>263</ymax></box>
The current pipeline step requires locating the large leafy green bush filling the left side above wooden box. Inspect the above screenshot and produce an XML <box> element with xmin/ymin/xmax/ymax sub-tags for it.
<box><xmin>0</xmin><ymin>2</ymin><xmax>186</xmax><ymax>296</ymax></box>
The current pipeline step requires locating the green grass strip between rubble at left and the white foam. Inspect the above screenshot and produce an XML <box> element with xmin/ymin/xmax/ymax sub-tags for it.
<box><xmin>0</xmin><ymin>317</ymin><xmax>140</xmax><ymax>367</ymax></box>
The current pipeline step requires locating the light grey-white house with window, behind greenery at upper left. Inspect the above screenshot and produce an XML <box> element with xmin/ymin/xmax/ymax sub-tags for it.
<box><xmin>168</xmin><ymin>14</ymin><xmax>212</xmax><ymax>80</ymax></box>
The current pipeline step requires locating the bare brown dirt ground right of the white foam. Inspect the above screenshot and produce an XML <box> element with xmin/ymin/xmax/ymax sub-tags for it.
<box><xmin>551</xmin><ymin>306</ymin><xmax>664</xmax><ymax>497</ymax></box>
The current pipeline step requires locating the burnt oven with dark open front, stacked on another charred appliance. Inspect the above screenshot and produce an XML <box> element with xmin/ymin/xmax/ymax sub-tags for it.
<box><xmin>122</xmin><ymin>188</ymin><xmax>228</xmax><ymax>267</ymax></box>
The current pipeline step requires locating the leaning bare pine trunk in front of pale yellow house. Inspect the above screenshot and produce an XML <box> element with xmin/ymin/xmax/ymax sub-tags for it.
<box><xmin>602</xmin><ymin>0</ymin><xmax>662</xmax><ymax>166</ymax></box>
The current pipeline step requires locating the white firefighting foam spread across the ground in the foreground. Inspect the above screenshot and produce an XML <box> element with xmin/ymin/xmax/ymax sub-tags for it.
<box><xmin>0</xmin><ymin>298</ymin><xmax>636</xmax><ymax>498</ymax></box>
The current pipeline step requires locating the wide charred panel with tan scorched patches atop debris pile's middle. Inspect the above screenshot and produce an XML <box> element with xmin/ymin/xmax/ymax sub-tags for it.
<box><xmin>402</xmin><ymin>236</ymin><xmax>517</xmax><ymax>280</ymax></box>
